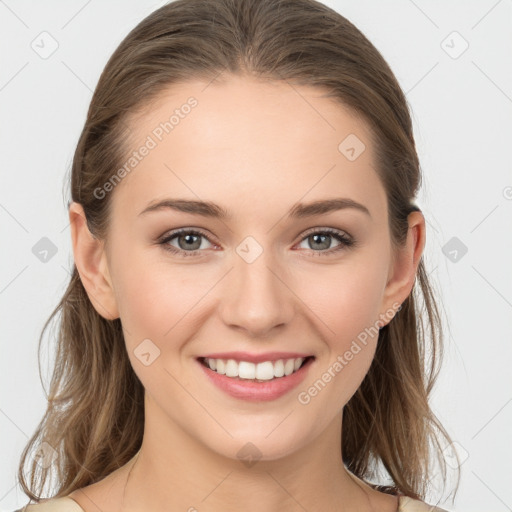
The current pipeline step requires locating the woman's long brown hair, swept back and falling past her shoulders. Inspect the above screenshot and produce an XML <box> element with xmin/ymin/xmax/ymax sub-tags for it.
<box><xmin>18</xmin><ymin>0</ymin><xmax>460</xmax><ymax>501</ymax></box>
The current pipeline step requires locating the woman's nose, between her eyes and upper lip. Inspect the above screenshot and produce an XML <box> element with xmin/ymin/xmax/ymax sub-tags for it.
<box><xmin>219</xmin><ymin>246</ymin><xmax>298</xmax><ymax>337</ymax></box>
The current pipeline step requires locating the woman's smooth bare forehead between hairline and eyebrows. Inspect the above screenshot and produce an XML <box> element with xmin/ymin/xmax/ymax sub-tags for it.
<box><xmin>113</xmin><ymin>77</ymin><xmax>386</xmax><ymax>224</ymax></box>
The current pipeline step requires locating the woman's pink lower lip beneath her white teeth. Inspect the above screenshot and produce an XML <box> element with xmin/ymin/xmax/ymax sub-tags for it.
<box><xmin>197</xmin><ymin>358</ymin><xmax>314</xmax><ymax>402</ymax></box>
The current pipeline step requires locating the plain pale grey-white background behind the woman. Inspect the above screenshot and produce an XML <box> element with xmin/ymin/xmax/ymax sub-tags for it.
<box><xmin>0</xmin><ymin>0</ymin><xmax>512</xmax><ymax>512</ymax></box>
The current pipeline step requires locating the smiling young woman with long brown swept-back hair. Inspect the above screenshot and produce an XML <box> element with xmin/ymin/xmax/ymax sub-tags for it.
<box><xmin>19</xmin><ymin>0</ymin><xmax>460</xmax><ymax>512</ymax></box>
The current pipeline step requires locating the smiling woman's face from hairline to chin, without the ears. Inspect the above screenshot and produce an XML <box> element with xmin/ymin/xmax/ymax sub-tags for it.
<box><xmin>82</xmin><ymin>77</ymin><xmax>412</xmax><ymax>460</ymax></box>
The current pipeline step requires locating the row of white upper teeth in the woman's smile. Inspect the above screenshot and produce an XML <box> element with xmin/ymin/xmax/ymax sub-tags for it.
<box><xmin>205</xmin><ymin>357</ymin><xmax>304</xmax><ymax>380</ymax></box>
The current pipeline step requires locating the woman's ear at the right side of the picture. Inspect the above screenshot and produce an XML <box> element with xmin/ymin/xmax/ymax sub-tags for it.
<box><xmin>379</xmin><ymin>211</ymin><xmax>426</xmax><ymax>327</ymax></box>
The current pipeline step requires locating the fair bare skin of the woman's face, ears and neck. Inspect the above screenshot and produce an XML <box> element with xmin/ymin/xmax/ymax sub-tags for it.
<box><xmin>69</xmin><ymin>76</ymin><xmax>425</xmax><ymax>512</ymax></box>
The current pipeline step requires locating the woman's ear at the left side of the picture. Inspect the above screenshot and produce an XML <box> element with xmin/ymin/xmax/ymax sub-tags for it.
<box><xmin>69</xmin><ymin>201</ymin><xmax>119</xmax><ymax>320</ymax></box>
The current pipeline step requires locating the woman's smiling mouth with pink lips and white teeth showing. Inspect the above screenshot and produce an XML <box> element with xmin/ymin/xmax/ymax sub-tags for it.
<box><xmin>197</xmin><ymin>356</ymin><xmax>315</xmax><ymax>402</ymax></box>
